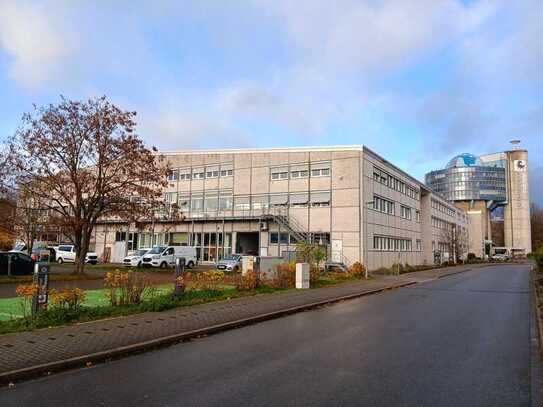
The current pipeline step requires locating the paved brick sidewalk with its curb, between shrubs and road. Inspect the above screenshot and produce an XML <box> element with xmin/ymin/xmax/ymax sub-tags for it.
<box><xmin>0</xmin><ymin>265</ymin><xmax>488</xmax><ymax>384</ymax></box>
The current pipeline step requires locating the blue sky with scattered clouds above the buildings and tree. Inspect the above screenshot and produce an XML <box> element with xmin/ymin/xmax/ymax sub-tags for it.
<box><xmin>0</xmin><ymin>0</ymin><xmax>543</xmax><ymax>206</ymax></box>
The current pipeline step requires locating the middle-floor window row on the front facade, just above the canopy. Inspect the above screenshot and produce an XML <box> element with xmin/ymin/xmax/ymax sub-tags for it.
<box><xmin>164</xmin><ymin>191</ymin><xmax>331</xmax><ymax>211</ymax></box>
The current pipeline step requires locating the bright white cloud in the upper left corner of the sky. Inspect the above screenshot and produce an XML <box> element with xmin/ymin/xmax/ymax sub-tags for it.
<box><xmin>0</xmin><ymin>0</ymin><xmax>74</xmax><ymax>87</ymax></box>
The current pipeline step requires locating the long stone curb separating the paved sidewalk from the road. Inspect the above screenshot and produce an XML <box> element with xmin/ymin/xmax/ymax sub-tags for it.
<box><xmin>0</xmin><ymin>281</ymin><xmax>418</xmax><ymax>385</ymax></box>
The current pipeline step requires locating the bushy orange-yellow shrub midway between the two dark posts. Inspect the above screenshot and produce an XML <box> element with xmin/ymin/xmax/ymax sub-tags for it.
<box><xmin>104</xmin><ymin>270</ymin><xmax>155</xmax><ymax>306</ymax></box>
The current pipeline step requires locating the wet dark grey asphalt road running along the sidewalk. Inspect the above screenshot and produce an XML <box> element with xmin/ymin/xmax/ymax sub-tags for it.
<box><xmin>0</xmin><ymin>265</ymin><xmax>537</xmax><ymax>407</ymax></box>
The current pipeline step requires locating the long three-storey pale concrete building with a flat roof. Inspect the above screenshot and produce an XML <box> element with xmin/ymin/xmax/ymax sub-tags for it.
<box><xmin>93</xmin><ymin>146</ymin><xmax>468</xmax><ymax>270</ymax></box>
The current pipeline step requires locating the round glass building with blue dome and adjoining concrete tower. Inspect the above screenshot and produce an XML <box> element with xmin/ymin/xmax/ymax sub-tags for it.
<box><xmin>425</xmin><ymin>149</ymin><xmax>531</xmax><ymax>257</ymax></box>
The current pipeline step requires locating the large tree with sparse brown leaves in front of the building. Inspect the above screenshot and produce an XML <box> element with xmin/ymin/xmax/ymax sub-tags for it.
<box><xmin>6</xmin><ymin>97</ymin><xmax>168</xmax><ymax>273</ymax></box>
